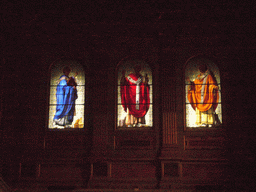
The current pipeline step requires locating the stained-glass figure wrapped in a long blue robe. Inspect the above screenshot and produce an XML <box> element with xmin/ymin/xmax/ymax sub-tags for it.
<box><xmin>53</xmin><ymin>67</ymin><xmax>77</xmax><ymax>128</ymax></box>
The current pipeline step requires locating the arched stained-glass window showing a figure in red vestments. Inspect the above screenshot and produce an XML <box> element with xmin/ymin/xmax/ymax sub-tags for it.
<box><xmin>117</xmin><ymin>59</ymin><xmax>153</xmax><ymax>128</ymax></box>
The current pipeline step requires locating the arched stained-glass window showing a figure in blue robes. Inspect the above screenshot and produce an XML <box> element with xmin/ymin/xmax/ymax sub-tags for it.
<box><xmin>48</xmin><ymin>60</ymin><xmax>85</xmax><ymax>129</ymax></box>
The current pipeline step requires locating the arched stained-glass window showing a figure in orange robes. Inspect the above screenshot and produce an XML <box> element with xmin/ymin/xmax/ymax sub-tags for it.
<box><xmin>185</xmin><ymin>57</ymin><xmax>222</xmax><ymax>128</ymax></box>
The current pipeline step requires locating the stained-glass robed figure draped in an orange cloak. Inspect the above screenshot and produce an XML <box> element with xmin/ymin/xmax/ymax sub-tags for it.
<box><xmin>186</xmin><ymin>64</ymin><xmax>219</xmax><ymax>127</ymax></box>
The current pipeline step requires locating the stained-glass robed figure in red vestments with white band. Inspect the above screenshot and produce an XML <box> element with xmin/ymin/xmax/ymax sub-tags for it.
<box><xmin>120</xmin><ymin>65</ymin><xmax>150</xmax><ymax>127</ymax></box>
